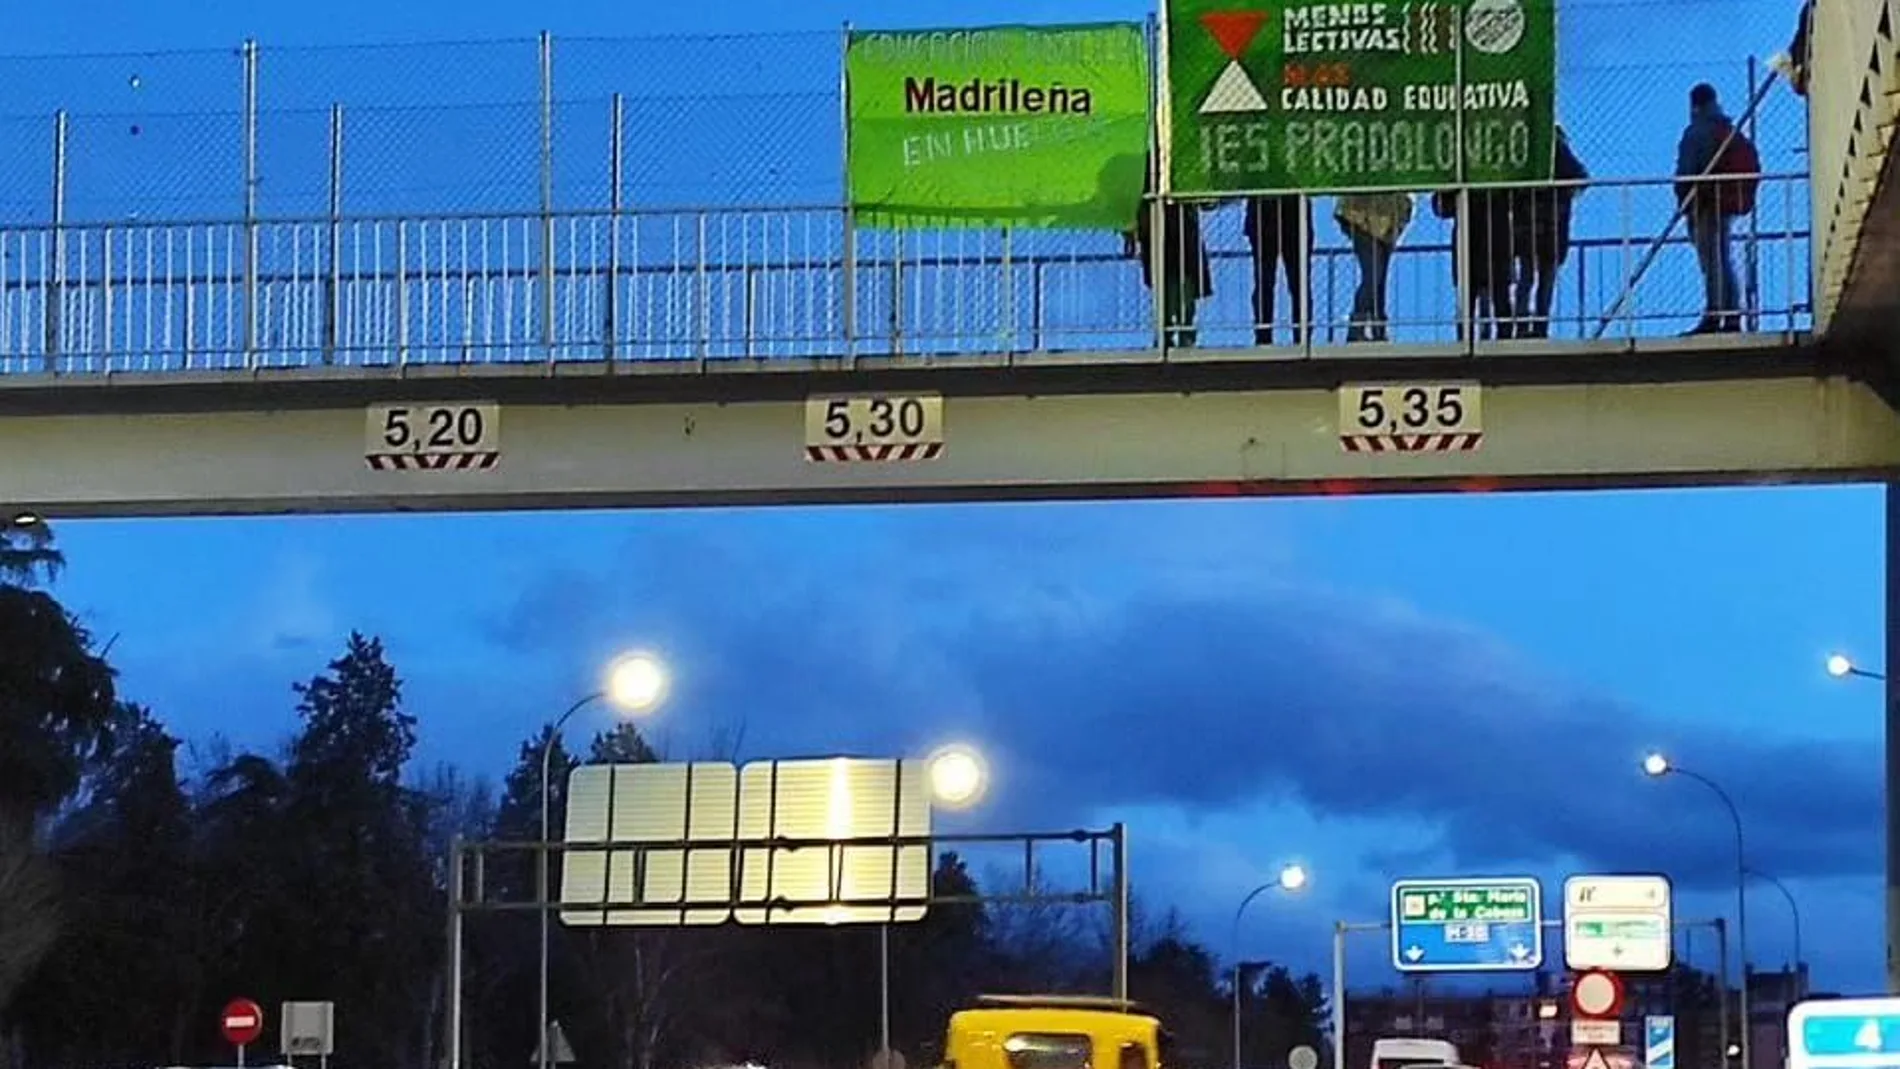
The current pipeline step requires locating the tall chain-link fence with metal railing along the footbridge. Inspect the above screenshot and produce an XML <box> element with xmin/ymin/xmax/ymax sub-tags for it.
<box><xmin>0</xmin><ymin>0</ymin><xmax>1809</xmax><ymax>370</ymax></box>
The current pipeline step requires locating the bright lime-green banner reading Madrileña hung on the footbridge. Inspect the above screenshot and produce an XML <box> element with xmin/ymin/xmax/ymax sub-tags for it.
<box><xmin>846</xmin><ymin>23</ymin><xmax>1150</xmax><ymax>230</ymax></box>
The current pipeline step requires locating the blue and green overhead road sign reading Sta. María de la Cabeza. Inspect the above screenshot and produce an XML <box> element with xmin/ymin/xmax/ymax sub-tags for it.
<box><xmin>1393</xmin><ymin>875</ymin><xmax>1543</xmax><ymax>972</ymax></box>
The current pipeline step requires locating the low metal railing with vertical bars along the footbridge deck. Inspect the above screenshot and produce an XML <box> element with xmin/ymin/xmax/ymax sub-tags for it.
<box><xmin>0</xmin><ymin>175</ymin><xmax>1809</xmax><ymax>376</ymax></box>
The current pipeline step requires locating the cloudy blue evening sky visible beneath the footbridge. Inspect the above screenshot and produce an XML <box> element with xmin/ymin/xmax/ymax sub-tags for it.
<box><xmin>40</xmin><ymin>488</ymin><xmax>1881</xmax><ymax>989</ymax></box>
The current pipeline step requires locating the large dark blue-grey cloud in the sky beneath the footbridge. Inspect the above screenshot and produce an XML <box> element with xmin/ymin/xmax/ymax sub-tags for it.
<box><xmin>486</xmin><ymin>507</ymin><xmax>1881</xmax><ymax>900</ymax></box>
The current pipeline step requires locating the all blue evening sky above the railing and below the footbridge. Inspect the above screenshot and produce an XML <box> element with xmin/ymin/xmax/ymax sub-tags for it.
<box><xmin>0</xmin><ymin>0</ymin><xmax>1854</xmax><ymax>1010</ymax></box>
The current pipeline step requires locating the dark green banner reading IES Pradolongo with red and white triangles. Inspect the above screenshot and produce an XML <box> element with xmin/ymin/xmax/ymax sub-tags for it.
<box><xmin>1165</xmin><ymin>0</ymin><xmax>1556</xmax><ymax>194</ymax></box>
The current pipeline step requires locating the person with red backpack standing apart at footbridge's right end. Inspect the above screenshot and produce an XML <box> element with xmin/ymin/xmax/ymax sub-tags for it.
<box><xmin>1676</xmin><ymin>82</ymin><xmax>1761</xmax><ymax>334</ymax></box>
